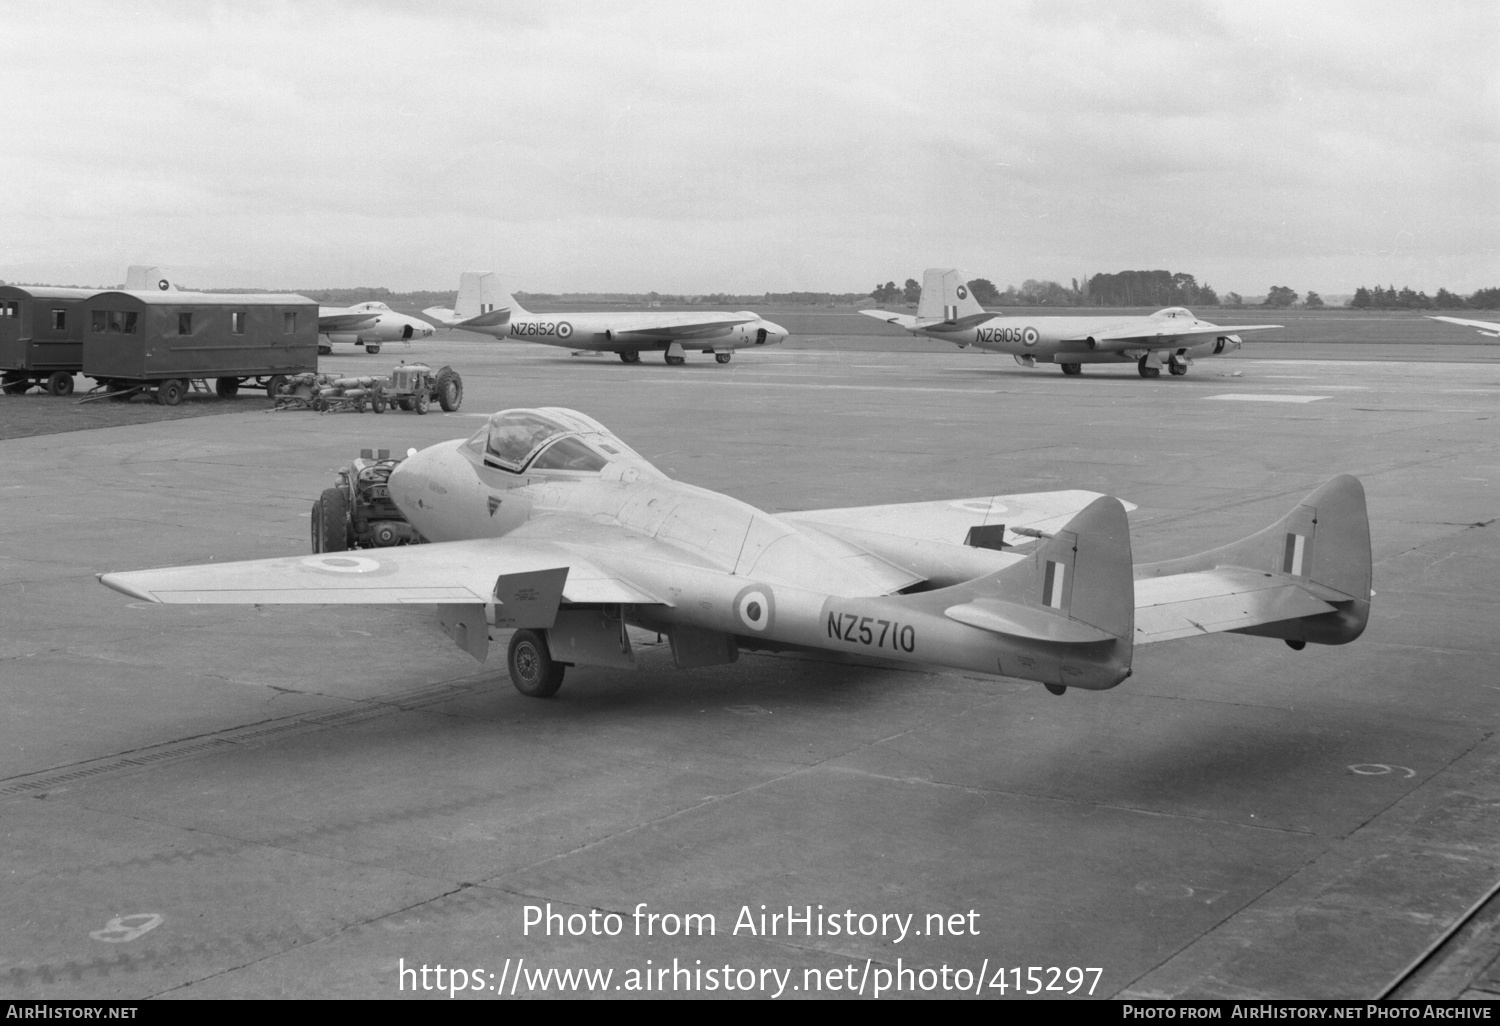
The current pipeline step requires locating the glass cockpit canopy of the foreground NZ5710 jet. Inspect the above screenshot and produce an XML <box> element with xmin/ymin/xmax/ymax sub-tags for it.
<box><xmin>468</xmin><ymin>407</ymin><xmax>638</xmax><ymax>474</ymax></box>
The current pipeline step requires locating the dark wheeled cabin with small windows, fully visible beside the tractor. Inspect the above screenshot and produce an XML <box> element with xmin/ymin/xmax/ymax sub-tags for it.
<box><xmin>83</xmin><ymin>291</ymin><xmax>318</xmax><ymax>405</ymax></box>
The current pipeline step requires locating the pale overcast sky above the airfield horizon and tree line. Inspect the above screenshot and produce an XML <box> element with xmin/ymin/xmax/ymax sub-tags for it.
<box><xmin>0</xmin><ymin>0</ymin><xmax>1500</xmax><ymax>296</ymax></box>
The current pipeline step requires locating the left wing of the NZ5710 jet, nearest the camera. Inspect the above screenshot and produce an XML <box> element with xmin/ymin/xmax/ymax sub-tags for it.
<box><xmin>99</xmin><ymin>539</ymin><xmax>668</xmax><ymax>605</ymax></box>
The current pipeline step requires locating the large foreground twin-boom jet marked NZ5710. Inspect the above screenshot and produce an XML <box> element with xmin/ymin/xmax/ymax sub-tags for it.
<box><xmin>101</xmin><ymin>408</ymin><xmax>1371</xmax><ymax>698</ymax></box>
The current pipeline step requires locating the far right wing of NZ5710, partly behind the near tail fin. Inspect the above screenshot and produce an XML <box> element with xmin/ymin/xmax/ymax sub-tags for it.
<box><xmin>780</xmin><ymin>489</ymin><xmax>1136</xmax><ymax>545</ymax></box>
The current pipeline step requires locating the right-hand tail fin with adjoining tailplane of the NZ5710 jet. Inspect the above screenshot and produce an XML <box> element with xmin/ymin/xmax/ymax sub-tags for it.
<box><xmin>1136</xmin><ymin>474</ymin><xmax>1373</xmax><ymax>648</ymax></box>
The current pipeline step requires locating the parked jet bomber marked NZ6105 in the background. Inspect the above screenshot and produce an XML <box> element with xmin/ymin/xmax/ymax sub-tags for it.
<box><xmin>860</xmin><ymin>267</ymin><xmax>1281</xmax><ymax>378</ymax></box>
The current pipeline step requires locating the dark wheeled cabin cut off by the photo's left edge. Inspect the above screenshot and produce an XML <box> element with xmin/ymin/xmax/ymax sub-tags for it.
<box><xmin>0</xmin><ymin>285</ymin><xmax>98</xmax><ymax>396</ymax></box>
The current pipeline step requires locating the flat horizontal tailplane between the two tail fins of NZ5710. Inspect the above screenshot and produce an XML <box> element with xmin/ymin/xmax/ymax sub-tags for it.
<box><xmin>1136</xmin><ymin>567</ymin><xmax>1349</xmax><ymax>645</ymax></box>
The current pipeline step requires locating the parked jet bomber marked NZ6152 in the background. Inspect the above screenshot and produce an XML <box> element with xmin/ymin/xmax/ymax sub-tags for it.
<box><xmin>423</xmin><ymin>272</ymin><xmax>786</xmax><ymax>366</ymax></box>
